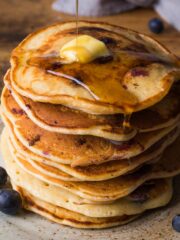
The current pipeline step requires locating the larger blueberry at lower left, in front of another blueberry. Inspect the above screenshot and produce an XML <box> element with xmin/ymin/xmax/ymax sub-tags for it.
<box><xmin>0</xmin><ymin>189</ymin><xmax>22</xmax><ymax>215</ymax></box>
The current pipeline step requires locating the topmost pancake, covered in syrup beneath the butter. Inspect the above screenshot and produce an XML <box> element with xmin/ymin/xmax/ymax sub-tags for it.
<box><xmin>10</xmin><ymin>21</ymin><xmax>180</xmax><ymax>114</ymax></box>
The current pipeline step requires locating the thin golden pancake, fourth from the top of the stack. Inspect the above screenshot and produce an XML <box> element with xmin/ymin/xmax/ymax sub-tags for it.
<box><xmin>5</xmin><ymin>126</ymin><xmax>179</xmax><ymax>181</ymax></box>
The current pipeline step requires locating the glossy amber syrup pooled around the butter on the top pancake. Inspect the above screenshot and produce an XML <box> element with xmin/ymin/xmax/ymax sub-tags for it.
<box><xmin>26</xmin><ymin>27</ymin><xmax>172</xmax><ymax>114</ymax></box>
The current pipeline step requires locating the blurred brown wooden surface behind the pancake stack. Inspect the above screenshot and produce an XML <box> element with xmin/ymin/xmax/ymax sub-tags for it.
<box><xmin>0</xmin><ymin>0</ymin><xmax>180</xmax><ymax>84</ymax></box>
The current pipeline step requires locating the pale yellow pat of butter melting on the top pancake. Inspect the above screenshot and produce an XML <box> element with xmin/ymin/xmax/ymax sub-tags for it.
<box><xmin>60</xmin><ymin>35</ymin><xmax>110</xmax><ymax>63</ymax></box>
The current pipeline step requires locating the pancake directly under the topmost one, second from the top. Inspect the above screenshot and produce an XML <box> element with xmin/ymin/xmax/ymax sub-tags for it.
<box><xmin>3</xmin><ymin>75</ymin><xmax>137</xmax><ymax>141</ymax></box>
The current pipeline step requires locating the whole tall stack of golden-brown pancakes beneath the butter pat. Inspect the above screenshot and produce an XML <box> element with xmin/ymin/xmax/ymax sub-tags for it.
<box><xmin>1</xmin><ymin>22</ymin><xmax>180</xmax><ymax>228</ymax></box>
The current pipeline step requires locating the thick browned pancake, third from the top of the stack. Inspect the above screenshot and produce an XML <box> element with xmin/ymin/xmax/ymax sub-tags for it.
<box><xmin>1</xmin><ymin>92</ymin><xmax>179</xmax><ymax>166</ymax></box>
